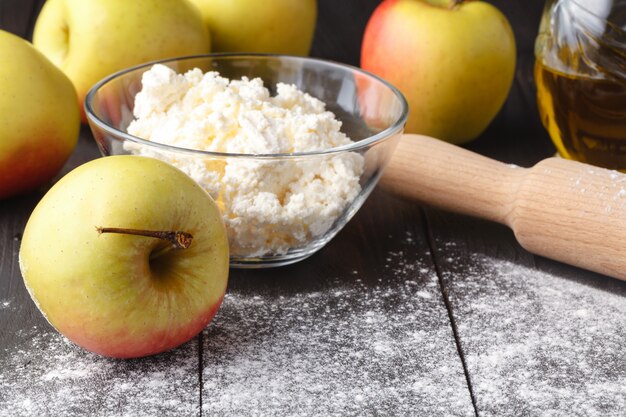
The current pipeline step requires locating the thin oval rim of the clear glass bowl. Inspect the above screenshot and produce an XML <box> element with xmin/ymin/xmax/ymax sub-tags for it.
<box><xmin>83</xmin><ymin>53</ymin><xmax>409</xmax><ymax>159</ymax></box>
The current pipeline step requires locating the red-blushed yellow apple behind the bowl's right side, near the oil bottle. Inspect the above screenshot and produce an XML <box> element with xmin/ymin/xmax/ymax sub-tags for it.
<box><xmin>361</xmin><ymin>0</ymin><xmax>516</xmax><ymax>144</ymax></box>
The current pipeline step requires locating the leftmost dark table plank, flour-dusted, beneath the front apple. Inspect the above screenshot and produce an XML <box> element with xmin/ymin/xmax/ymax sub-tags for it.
<box><xmin>0</xmin><ymin>131</ymin><xmax>200</xmax><ymax>416</ymax></box>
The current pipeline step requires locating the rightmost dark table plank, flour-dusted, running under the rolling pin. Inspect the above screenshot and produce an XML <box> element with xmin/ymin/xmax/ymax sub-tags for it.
<box><xmin>426</xmin><ymin>0</ymin><xmax>626</xmax><ymax>416</ymax></box>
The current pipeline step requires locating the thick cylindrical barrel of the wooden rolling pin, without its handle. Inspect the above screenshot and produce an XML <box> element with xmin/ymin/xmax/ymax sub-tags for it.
<box><xmin>508</xmin><ymin>158</ymin><xmax>626</xmax><ymax>280</ymax></box>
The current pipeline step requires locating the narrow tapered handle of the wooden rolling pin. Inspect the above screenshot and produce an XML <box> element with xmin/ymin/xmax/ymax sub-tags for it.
<box><xmin>379</xmin><ymin>134</ymin><xmax>524</xmax><ymax>224</ymax></box>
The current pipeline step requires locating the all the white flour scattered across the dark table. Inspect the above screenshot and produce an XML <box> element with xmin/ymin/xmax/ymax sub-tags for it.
<box><xmin>0</xmin><ymin>228</ymin><xmax>626</xmax><ymax>417</ymax></box>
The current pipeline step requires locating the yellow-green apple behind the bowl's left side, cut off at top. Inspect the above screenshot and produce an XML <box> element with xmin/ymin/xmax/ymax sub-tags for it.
<box><xmin>33</xmin><ymin>0</ymin><xmax>211</xmax><ymax>121</ymax></box>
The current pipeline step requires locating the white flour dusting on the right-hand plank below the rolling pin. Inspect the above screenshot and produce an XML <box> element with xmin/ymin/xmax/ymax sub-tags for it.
<box><xmin>446</xmin><ymin>255</ymin><xmax>626</xmax><ymax>417</ymax></box>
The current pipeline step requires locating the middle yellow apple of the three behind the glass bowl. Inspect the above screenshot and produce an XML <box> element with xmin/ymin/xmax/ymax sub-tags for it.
<box><xmin>186</xmin><ymin>0</ymin><xmax>317</xmax><ymax>55</ymax></box>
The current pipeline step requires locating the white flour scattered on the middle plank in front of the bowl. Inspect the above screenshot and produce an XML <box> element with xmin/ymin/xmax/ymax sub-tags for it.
<box><xmin>203</xmin><ymin>264</ymin><xmax>474</xmax><ymax>416</ymax></box>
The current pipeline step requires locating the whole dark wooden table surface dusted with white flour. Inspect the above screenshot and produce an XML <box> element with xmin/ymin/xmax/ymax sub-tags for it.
<box><xmin>0</xmin><ymin>0</ymin><xmax>626</xmax><ymax>416</ymax></box>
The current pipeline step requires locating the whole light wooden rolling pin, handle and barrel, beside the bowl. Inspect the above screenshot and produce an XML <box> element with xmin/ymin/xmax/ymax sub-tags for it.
<box><xmin>380</xmin><ymin>135</ymin><xmax>626</xmax><ymax>280</ymax></box>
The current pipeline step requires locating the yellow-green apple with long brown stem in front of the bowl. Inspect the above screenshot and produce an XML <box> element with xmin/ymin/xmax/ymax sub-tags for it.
<box><xmin>19</xmin><ymin>155</ymin><xmax>229</xmax><ymax>358</ymax></box>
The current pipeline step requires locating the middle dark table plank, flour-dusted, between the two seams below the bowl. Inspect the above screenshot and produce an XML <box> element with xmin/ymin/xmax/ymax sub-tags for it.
<box><xmin>202</xmin><ymin>192</ymin><xmax>474</xmax><ymax>416</ymax></box>
